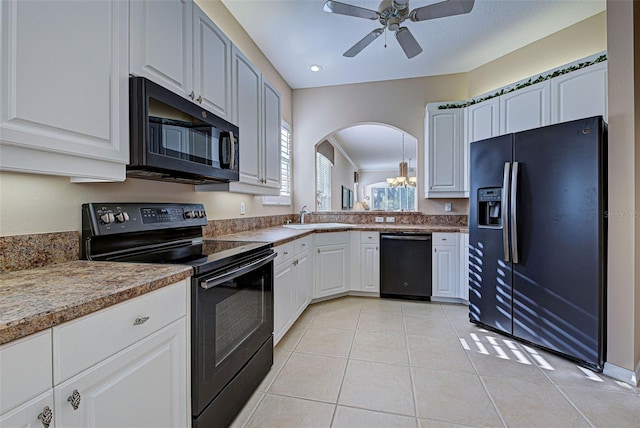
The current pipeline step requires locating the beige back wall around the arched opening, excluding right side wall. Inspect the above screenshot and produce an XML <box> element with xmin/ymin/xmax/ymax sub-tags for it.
<box><xmin>293</xmin><ymin>74</ymin><xmax>467</xmax><ymax>213</ymax></box>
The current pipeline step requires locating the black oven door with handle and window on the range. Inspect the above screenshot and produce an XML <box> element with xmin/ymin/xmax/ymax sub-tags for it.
<box><xmin>191</xmin><ymin>250</ymin><xmax>276</xmax><ymax>416</ymax></box>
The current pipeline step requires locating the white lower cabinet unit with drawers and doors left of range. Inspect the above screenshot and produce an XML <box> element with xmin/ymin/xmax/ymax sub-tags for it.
<box><xmin>0</xmin><ymin>279</ymin><xmax>191</xmax><ymax>428</ymax></box>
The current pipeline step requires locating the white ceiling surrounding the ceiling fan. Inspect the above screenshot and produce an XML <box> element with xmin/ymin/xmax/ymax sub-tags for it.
<box><xmin>222</xmin><ymin>0</ymin><xmax>606</xmax><ymax>89</ymax></box>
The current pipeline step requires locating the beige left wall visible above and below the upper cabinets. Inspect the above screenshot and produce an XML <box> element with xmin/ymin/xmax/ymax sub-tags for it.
<box><xmin>0</xmin><ymin>0</ymin><xmax>293</xmax><ymax>236</ymax></box>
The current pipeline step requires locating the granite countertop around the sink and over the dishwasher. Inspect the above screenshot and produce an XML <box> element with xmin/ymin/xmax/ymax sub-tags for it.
<box><xmin>215</xmin><ymin>223</ymin><xmax>468</xmax><ymax>246</ymax></box>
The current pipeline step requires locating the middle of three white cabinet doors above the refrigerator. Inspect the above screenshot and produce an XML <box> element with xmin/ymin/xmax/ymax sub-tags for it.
<box><xmin>500</xmin><ymin>80</ymin><xmax>551</xmax><ymax>134</ymax></box>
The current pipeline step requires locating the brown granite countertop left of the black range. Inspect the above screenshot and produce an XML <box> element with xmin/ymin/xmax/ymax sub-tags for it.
<box><xmin>0</xmin><ymin>260</ymin><xmax>193</xmax><ymax>345</ymax></box>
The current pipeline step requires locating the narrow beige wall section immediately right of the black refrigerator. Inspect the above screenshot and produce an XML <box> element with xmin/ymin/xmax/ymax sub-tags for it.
<box><xmin>607</xmin><ymin>0</ymin><xmax>640</xmax><ymax>378</ymax></box>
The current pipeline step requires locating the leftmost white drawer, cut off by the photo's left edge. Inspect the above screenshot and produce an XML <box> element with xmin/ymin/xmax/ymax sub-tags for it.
<box><xmin>0</xmin><ymin>330</ymin><xmax>52</xmax><ymax>414</ymax></box>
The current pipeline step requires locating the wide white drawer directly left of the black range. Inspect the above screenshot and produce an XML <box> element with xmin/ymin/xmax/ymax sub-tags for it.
<box><xmin>53</xmin><ymin>279</ymin><xmax>189</xmax><ymax>385</ymax></box>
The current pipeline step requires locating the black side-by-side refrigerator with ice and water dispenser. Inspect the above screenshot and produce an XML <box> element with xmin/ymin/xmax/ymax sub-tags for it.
<box><xmin>469</xmin><ymin>116</ymin><xmax>607</xmax><ymax>371</ymax></box>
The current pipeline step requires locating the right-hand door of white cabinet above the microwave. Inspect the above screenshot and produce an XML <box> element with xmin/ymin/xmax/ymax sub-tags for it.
<box><xmin>193</xmin><ymin>6</ymin><xmax>235</xmax><ymax>123</ymax></box>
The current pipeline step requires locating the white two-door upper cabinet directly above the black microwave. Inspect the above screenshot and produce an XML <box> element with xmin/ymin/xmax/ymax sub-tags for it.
<box><xmin>130</xmin><ymin>0</ymin><xmax>234</xmax><ymax>122</ymax></box>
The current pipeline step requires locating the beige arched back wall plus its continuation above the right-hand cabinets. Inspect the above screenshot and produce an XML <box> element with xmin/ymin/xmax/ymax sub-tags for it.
<box><xmin>293</xmin><ymin>13</ymin><xmax>607</xmax><ymax>214</ymax></box>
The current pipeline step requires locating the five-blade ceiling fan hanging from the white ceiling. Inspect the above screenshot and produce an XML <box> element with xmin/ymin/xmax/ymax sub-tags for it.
<box><xmin>323</xmin><ymin>0</ymin><xmax>475</xmax><ymax>59</ymax></box>
